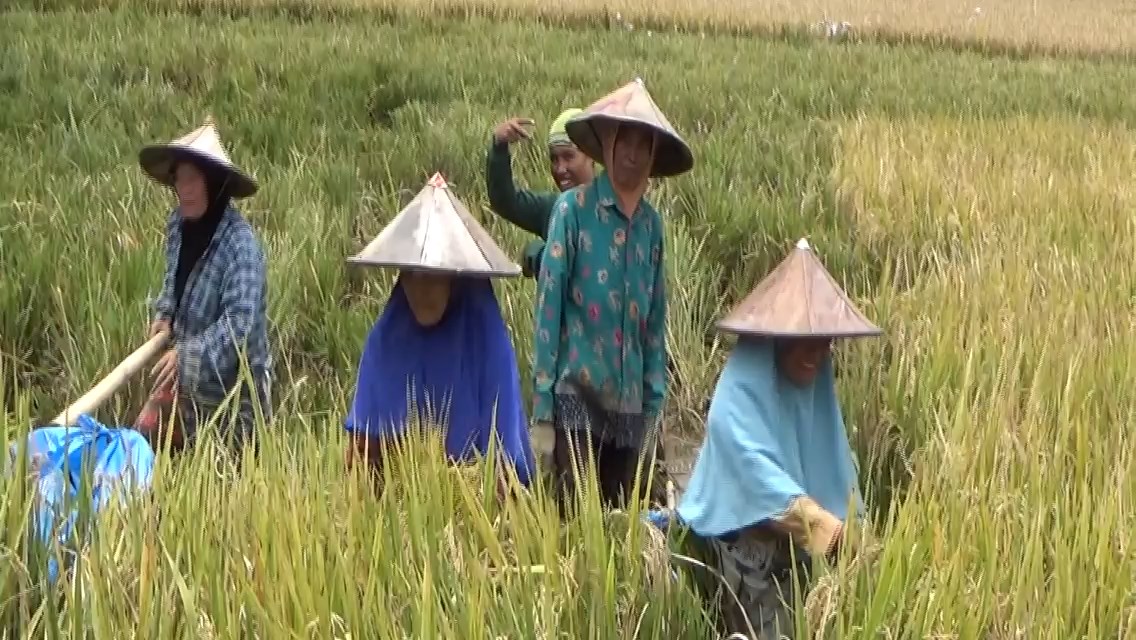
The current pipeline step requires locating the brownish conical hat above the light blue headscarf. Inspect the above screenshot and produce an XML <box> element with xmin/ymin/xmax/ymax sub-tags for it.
<box><xmin>718</xmin><ymin>239</ymin><xmax>883</xmax><ymax>338</ymax></box>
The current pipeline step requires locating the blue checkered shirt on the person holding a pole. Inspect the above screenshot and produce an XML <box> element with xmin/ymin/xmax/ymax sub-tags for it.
<box><xmin>153</xmin><ymin>208</ymin><xmax>272</xmax><ymax>413</ymax></box>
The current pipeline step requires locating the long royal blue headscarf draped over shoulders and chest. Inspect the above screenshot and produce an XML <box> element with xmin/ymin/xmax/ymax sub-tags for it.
<box><xmin>344</xmin><ymin>277</ymin><xmax>534</xmax><ymax>485</ymax></box>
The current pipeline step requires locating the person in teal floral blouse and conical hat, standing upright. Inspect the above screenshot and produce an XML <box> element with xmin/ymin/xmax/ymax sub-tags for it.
<box><xmin>533</xmin><ymin>81</ymin><xmax>693</xmax><ymax>509</ymax></box>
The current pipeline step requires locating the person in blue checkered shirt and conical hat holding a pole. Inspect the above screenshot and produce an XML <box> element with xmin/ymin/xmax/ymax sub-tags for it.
<box><xmin>135</xmin><ymin>117</ymin><xmax>272</xmax><ymax>448</ymax></box>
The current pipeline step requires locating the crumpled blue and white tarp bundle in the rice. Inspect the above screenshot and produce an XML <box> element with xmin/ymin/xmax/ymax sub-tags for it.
<box><xmin>9</xmin><ymin>414</ymin><xmax>154</xmax><ymax>582</ymax></box>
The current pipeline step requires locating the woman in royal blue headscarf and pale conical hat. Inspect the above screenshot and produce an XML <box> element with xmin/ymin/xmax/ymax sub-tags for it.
<box><xmin>345</xmin><ymin>174</ymin><xmax>534</xmax><ymax>487</ymax></box>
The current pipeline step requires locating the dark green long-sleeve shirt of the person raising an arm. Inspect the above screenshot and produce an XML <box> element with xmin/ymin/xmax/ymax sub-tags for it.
<box><xmin>485</xmin><ymin>141</ymin><xmax>560</xmax><ymax>277</ymax></box>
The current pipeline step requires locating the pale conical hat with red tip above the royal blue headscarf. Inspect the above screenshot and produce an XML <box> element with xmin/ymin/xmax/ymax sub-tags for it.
<box><xmin>348</xmin><ymin>173</ymin><xmax>520</xmax><ymax>277</ymax></box>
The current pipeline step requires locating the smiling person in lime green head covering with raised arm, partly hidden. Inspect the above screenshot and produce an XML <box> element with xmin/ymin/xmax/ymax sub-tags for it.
<box><xmin>485</xmin><ymin>108</ymin><xmax>595</xmax><ymax>277</ymax></box>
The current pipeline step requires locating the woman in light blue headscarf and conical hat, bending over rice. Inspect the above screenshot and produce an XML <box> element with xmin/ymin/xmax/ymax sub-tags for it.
<box><xmin>677</xmin><ymin>240</ymin><xmax>880</xmax><ymax>640</ymax></box>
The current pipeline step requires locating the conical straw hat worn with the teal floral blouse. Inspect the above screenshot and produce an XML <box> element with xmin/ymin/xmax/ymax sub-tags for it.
<box><xmin>565</xmin><ymin>78</ymin><xmax>694</xmax><ymax>177</ymax></box>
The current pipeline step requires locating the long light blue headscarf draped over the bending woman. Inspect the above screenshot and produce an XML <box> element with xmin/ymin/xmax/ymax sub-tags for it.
<box><xmin>678</xmin><ymin>336</ymin><xmax>862</xmax><ymax>537</ymax></box>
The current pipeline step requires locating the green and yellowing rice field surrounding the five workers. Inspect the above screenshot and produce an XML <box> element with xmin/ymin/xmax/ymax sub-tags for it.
<box><xmin>0</xmin><ymin>0</ymin><xmax>1136</xmax><ymax>640</ymax></box>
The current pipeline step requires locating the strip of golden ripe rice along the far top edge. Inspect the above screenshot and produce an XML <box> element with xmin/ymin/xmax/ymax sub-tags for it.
<box><xmin>20</xmin><ymin>0</ymin><xmax>1136</xmax><ymax>59</ymax></box>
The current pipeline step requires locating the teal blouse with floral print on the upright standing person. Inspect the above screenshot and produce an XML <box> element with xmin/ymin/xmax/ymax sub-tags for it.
<box><xmin>533</xmin><ymin>172</ymin><xmax>667</xmax><ymax>436</ymax></box>
